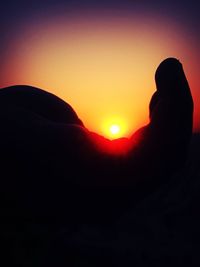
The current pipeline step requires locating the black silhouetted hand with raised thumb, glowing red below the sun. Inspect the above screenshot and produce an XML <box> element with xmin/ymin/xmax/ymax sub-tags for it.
<box><xmin>0</xmin><ymin>58</ymin><xmax>193</xmax><ymax>266</ymax></box>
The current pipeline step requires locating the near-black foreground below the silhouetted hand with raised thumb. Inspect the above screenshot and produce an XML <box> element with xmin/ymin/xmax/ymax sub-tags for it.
<box><xmin>1</xmin><ymin>134</ymin><xmax>200</xmax><ymax>266</ymax></box>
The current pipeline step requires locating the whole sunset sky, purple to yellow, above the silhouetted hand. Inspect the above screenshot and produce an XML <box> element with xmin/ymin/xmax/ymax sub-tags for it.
<box><xmin>0</xmin><ymin>0</ymin><xmax>200</xmax><ymax>137</ymax></box>
